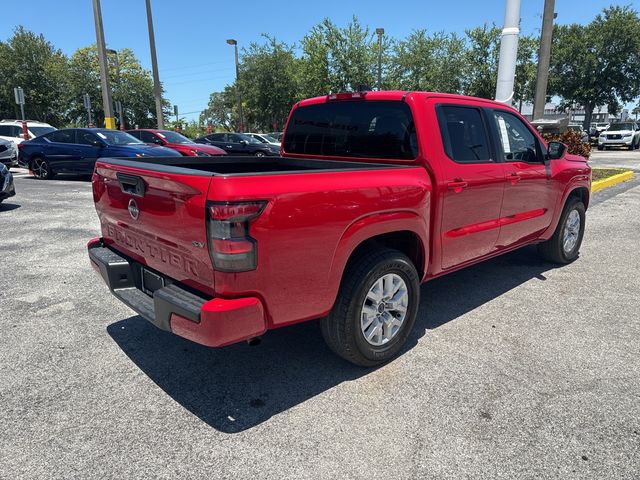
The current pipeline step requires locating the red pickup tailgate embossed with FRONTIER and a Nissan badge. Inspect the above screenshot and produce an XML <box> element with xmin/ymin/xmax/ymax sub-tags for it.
<box><xmin>93</xmin><ymin>160</ymin><xmax>214</xmax><ymax>295</ymax></box>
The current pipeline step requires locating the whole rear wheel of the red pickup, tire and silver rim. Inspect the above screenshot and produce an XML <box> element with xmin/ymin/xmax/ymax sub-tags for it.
<box><xmin>321</xmin><ymin>249</ymin><xmax>420</xmax><ymax>367</ymax></box>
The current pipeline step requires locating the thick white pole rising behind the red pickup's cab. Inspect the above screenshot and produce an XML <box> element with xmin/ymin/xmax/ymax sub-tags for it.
<box><xmin>496</xmin><ymin>0</ymin><xmax>520</xmax><ymax>105</ymax></box>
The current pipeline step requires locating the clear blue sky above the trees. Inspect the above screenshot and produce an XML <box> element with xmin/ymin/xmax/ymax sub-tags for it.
<box><xmin>0</xmin><ymin>0</ymin><xmax>640</xmax><ymax>119</ymax></box>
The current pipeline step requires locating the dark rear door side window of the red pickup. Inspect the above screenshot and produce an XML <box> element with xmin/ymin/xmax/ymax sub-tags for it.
<box><xmin>437</xmin><ymin>105</ymin><xmax>493</xmax><ymax>163</ymax></box>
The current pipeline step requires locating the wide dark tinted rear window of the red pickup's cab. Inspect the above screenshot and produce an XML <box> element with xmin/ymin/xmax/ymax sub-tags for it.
<box><xmin>283</xmin><ymin>100</ymin><xmax>418</xmax><ymax>160</ymax></box>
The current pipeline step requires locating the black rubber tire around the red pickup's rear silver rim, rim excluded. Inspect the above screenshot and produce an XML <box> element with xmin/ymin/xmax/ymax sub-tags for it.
<box><xmin>320</xmin><ymin>248</ymin><xmax>420</xmax><ymax>367</ymax></box>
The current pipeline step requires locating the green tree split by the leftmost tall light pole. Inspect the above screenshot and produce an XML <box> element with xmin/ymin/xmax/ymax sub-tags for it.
<box><xmin>67</xmin><ymin>45</ymin><xmax>160</xmax><ymax>128</ymax></box>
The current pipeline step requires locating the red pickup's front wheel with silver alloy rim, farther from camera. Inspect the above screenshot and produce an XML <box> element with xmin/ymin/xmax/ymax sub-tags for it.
<box><xmin>538</xmin><ymin>197</ymin><xmax>586</xmax><ymax>264</ymax></box>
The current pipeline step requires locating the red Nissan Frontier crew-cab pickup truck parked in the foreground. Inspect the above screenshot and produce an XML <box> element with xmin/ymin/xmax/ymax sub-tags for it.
<box><xmin>88</xmin><ymin>91</ymin><xmax>591</xmax><ymax>366</ymax></box>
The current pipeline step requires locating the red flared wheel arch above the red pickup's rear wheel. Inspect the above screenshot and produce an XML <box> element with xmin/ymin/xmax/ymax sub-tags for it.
<box><xmin>328</xmin><ymin>211</ymin><xmax>429</xmax><ymax>306</ymax></box>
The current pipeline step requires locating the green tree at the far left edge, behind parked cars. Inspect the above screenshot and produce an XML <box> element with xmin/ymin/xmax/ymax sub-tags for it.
<box><xmin>0</xmin><ymin>26</ymin><xmax>69</xmax><ymax>126</ymax></box>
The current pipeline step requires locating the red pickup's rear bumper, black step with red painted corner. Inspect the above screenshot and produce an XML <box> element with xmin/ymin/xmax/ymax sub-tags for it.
<box><xmin>87</xmin><ymin>238</ymin><xmax>266</xmax><ymax>347</ymax></box>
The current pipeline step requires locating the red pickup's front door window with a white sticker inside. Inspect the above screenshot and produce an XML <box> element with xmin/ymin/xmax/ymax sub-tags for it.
<box><xmin>493</xmin><ymin>110</ymin><xmax>538</xmax><ymax>162</ymax></box>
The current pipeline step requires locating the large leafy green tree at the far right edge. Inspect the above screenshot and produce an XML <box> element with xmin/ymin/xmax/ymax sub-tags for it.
<box><xmin>549</xmin><ymin>6</ymin><xmax>640</xmax><ymax>128</ymax></box>
